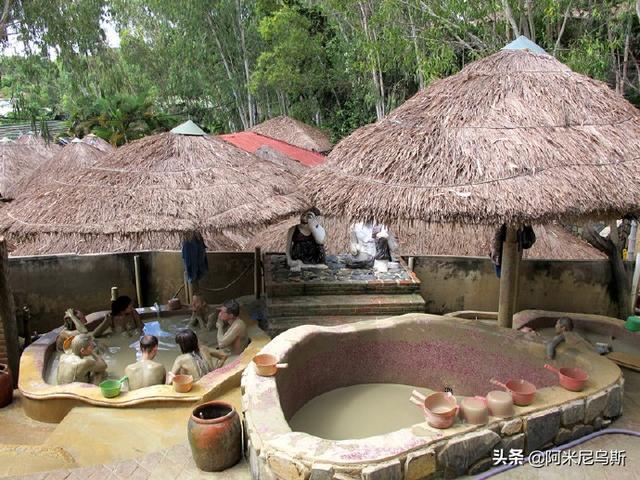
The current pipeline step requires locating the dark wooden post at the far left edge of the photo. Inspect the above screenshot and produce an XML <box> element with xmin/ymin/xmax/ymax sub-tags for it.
<box><xmin>0</xmin><ymin>237</ymin><xmax>20</xmax><ymax>387</ymax></box>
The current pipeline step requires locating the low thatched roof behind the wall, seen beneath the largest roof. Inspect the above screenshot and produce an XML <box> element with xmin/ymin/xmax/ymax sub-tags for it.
<box><xmin>245</xmin><ymin>217</ymin><xmax>607</xmax><ymax>260</ymax></box>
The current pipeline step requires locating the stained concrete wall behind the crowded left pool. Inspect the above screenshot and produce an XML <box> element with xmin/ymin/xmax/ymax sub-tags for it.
<box><xmin>9</xmin><ymin>251</ymin><xmax>253</xmax><ymax>332</ymax></box>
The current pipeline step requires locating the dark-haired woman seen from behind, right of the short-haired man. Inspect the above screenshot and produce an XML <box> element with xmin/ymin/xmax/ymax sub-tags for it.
<box><xmin>167</xmin><ymin>328</ymin><xmax>227</xmax><ymax>383</ymax></box>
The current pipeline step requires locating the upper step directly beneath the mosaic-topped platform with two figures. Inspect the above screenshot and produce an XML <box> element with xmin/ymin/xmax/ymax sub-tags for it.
<box><xmin>265</xmin><ymin>280</ymin><xmax>420</xmax><ymax>297</ymax></box>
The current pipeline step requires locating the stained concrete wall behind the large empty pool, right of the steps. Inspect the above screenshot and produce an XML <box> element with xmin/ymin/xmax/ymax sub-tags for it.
<box><xmin>414</xmin><ymin>257</ymin><xmax>617</xmax><ymax>317</ymax></box>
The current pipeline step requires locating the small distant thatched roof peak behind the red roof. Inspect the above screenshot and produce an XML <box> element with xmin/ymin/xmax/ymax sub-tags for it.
<box><xmin>249</xmin><ymin>115</ymin><xmax>333</xmax><ymax>153</ymax></box>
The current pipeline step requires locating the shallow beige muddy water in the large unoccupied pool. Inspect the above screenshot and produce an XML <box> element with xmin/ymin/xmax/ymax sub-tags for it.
<box><xmin>289</xmin><ymin>383</ymin><xmax>424</xmax><ymax>440</ymax></box>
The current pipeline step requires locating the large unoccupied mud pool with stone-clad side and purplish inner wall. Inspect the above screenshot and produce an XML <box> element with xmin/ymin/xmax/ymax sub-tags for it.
<box><xmin>242</xmin><ymin>314</ymin><xmax>623</xmax><ymax>479</ymax></box>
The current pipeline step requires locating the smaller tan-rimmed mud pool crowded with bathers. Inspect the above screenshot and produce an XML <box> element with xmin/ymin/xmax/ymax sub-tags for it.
<box><xmin>18</xmin><ymin>307</ymin><xmax>269</xmax><ymax>423</ymax></box>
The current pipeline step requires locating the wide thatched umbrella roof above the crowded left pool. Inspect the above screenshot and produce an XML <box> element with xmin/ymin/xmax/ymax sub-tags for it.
<box><xmin>4</xmin><ymin>121</ymin><xmax>299</xmax><ymax>253</ymax></box>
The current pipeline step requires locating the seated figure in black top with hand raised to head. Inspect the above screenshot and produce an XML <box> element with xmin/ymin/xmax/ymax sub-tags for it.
<box><xmin>286</xmin><ymin>207</ymin><xmax>327</xmax><ymax>272</ymax></box>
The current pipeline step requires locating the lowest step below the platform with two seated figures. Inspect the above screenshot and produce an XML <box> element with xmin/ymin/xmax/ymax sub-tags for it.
<box><xmin>267</xmin><ymin>293</ymin><xmax>425</xmax><ymax>319</ymax></box>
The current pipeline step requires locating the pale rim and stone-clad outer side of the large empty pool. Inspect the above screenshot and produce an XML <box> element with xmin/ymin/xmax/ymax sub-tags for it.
<box><xmin>241</xmin><ymin>314</ymin><xmax>624</xmax><ymax>480</ymax></box>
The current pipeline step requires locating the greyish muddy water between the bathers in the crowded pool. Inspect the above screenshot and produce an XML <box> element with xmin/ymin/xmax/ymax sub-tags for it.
<box><xmin>45</xmin><ymin>316</ymin><xmax>237</xmax><ymax>384</ymax></box>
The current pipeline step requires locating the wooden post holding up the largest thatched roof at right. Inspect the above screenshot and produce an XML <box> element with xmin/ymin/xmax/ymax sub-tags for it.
<box><xmin>498</xmin><ymin>226</ymin><xmax>520</xmax><ymax>328</ymax></box>
